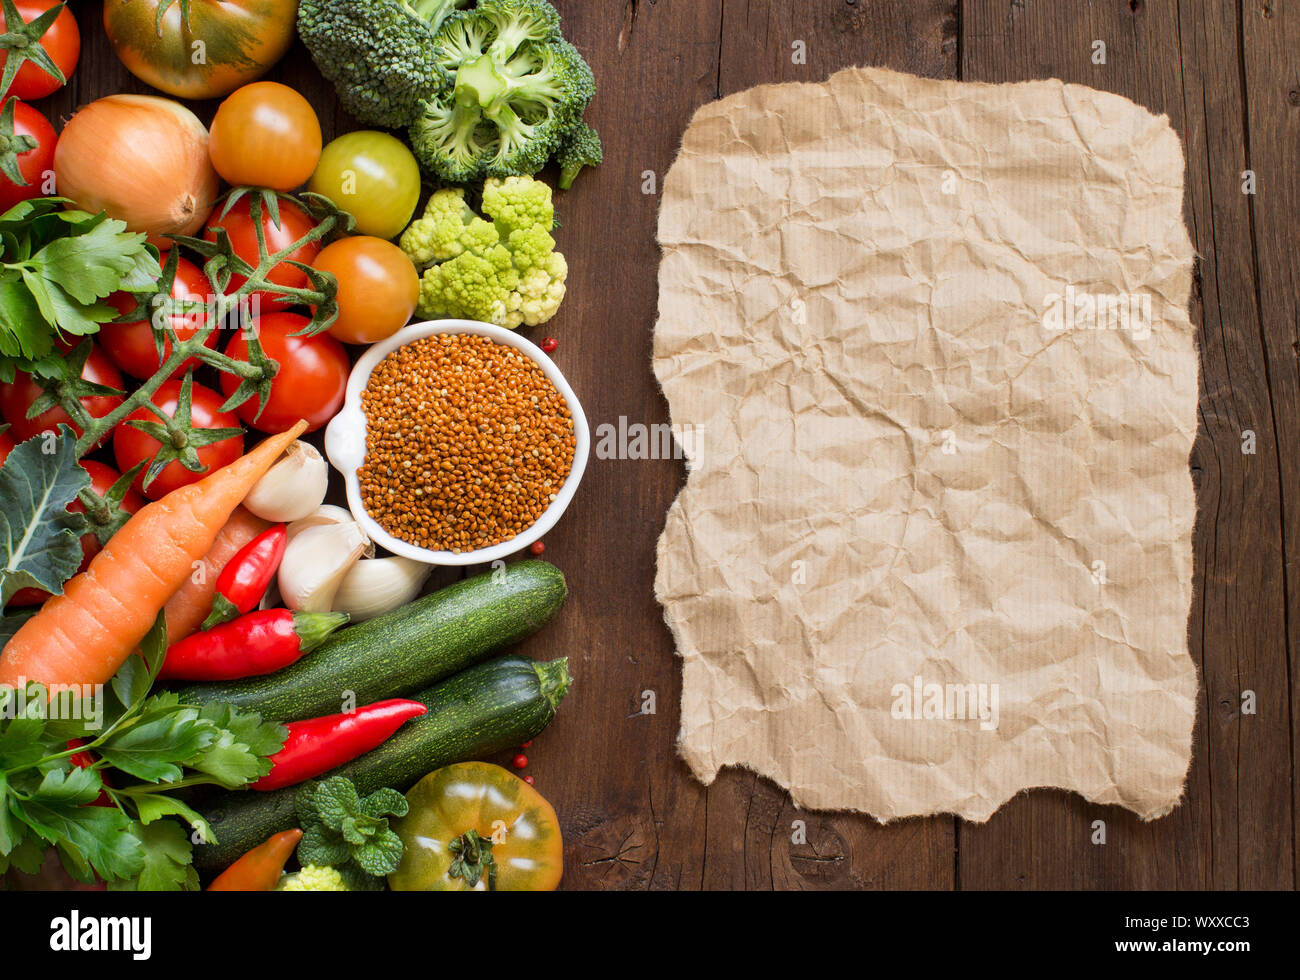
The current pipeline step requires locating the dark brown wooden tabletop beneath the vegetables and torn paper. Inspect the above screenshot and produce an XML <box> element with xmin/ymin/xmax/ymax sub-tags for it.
<box><xmin>58</xmin><ymin>0</ymin><xmax>1300</xmax><ymax>889</ymax></box>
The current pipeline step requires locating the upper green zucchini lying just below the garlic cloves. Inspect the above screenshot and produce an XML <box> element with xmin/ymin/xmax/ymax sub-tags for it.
<box><xmin>179</xmin><ymin>560</ymin><xmax>567</xmax><ymax>721</ymax></box>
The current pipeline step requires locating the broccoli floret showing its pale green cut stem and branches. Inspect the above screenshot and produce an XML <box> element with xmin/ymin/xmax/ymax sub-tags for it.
<box><xmin>411</xmin><ymin>0</ymin><xmax>595</xmax><ymax>183</ymax></box>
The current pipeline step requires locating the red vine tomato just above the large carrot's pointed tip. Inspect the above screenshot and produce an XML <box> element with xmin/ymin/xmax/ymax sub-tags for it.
<box><xmin>113</xmin><ymin>381</ymin><xmax>243</xmax><ymax>500</ymax></box>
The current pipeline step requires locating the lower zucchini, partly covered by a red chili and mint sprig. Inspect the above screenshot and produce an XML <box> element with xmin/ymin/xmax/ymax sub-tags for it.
<box><xmin>194</xmin><ymin>656</ymin><xmax>572</xmax><ymax>872</ymax></box>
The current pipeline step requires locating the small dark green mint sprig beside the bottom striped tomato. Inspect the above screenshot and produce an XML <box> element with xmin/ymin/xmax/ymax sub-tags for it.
<box><xmin>296</xmin><ymin>776</ymin><xmax>408</xmax><ymax>892</ymax></box>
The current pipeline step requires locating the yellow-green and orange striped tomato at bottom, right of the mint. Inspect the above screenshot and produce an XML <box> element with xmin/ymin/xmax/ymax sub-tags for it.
<box><xmin>389</xmin><ymin>762</ymin><xmax>564</xmax><ymax>892</ymax></box>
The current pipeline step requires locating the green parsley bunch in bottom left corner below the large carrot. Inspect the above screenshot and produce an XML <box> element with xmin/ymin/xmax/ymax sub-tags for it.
<box><xmin>0</xmin><ymin>615</ymin><xmax>286</xmax><ymax>890</ymax></box>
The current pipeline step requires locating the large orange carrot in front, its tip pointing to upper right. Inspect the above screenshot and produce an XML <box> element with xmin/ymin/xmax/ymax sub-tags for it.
<box><xmin>0</xmin><ymin>421</ymin><xmax>307</xmax><ymax>690</ymax></box>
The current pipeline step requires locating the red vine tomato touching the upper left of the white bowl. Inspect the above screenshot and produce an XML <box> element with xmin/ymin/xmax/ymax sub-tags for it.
<box><xmin>221</xmin><ymin>313</ymin><xmax>350</xmax><ymax>433</ymax></box>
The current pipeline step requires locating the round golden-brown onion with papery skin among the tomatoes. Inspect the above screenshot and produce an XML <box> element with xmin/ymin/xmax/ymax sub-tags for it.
<box><xmin>55</xmin><ymin>95</ymin><xmax>218</xmax><ymax>240</ymax></box>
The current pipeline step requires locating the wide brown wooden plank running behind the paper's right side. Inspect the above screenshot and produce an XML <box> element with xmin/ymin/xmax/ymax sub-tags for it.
<box><xmin>959</xmin><ymin>0</ymin><xmax>1296</xmax><ymax>888</ymax></box>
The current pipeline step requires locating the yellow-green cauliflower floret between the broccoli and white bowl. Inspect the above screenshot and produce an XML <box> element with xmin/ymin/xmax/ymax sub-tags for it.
<box><xmin>402</xmin><ymin>177</ymin><xmax>568</xmax><ymax>330</ymax></box>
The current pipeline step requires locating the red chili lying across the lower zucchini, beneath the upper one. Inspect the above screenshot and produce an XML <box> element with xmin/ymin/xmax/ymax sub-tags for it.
<box><xmin>252</xmin><ymin>698</ymin><xmax>429</xmax><ymax>790</ymax></box>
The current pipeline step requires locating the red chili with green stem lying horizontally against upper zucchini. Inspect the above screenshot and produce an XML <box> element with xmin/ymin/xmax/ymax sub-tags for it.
<box><xmin>159</xmin><ymin>610</ymin><xmax>348</xmax><ymax>681</ymax></box>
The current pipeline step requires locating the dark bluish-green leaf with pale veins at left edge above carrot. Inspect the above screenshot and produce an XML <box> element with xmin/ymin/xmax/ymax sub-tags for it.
<box><xmin>0</xmin><ymin>425</ymin><xmax>90</xmax><ymax>606</ymax></box>
